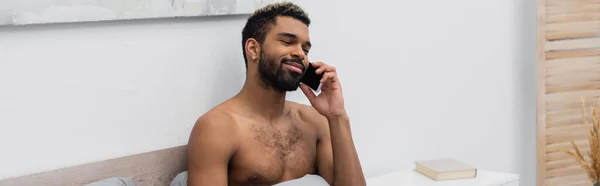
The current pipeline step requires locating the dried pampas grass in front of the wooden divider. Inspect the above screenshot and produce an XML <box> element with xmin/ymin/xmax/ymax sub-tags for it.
<box><xmin>564</xmin><ymin>97</ymin><xmax>600</xmax><ymax>184</ymax></box>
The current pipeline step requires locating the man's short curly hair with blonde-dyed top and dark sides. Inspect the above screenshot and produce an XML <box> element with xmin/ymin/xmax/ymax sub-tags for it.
<box><xmin>242</xmin><ymin>2</ymin><xmax>310</xmax><ymax>68</ymax></box>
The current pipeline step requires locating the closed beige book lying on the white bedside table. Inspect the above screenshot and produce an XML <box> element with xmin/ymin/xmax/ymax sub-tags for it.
<box><xmin>415</xmin><ymin>158</ymin><xmax>477</xmax><ymax>181</ymax></box>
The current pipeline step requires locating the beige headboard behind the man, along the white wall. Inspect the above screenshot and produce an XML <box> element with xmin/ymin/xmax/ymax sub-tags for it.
<box><xmin>0</xmin><ymin>145</ymin><xmax>187</xmax><ymax>186</ymax></box>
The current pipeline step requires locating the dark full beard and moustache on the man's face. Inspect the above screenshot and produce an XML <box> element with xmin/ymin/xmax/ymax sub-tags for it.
<box><xmin>258</xmin><ymin>52</ymin><xmax>304</xmax><ymax>92</ymax></box>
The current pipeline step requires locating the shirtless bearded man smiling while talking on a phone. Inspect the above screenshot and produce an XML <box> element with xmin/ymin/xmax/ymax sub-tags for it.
<box><xmin>188</xmin><ymin>3</ymin><xmax>366</xmax><ymax>186</ymax></box>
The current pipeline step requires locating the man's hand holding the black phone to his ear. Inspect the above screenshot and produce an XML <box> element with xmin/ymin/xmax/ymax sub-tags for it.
<box><xmin>300</xmin><ymin>62</ymin><xmax>346</xmax><ymax>119</ymax></box>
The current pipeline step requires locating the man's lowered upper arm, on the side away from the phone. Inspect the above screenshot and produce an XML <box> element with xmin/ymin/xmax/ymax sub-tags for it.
<box><xmin>188</xmin><ymin>115</ymin><xmax>236</xmax><ymax>186</ymax></box>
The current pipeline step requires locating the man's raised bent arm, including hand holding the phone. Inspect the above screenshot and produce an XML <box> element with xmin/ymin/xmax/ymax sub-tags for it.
<box><xmin>300</xmin><ymin>62</ymin><xmax>366</xmax><ymax>186</ymax></box>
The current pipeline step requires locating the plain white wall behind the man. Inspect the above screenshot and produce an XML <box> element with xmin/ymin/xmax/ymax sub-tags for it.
<box><xmin>0</xmin><ymin>0</ymin><xmax>535</xmax><ymax>185</ymax></box>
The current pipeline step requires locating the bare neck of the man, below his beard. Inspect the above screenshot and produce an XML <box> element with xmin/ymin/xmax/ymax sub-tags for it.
<box><xmin>236</xmin><ymin>76</ymin><xmax>286</xmax><ymax>121</ymax></box>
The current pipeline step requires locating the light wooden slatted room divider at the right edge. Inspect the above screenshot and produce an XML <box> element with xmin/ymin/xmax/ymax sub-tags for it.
<box><xmin>537</xmin><ymin>0</ymin><xmax>600</xmax><ymax>186</ymax></box>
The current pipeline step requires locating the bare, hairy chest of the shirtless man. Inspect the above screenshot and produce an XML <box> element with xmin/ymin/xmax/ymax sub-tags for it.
<box><xmin>229</xmin><ymin>121</ymin><xmax>318</xmax><ymax>185</ymax></box>
